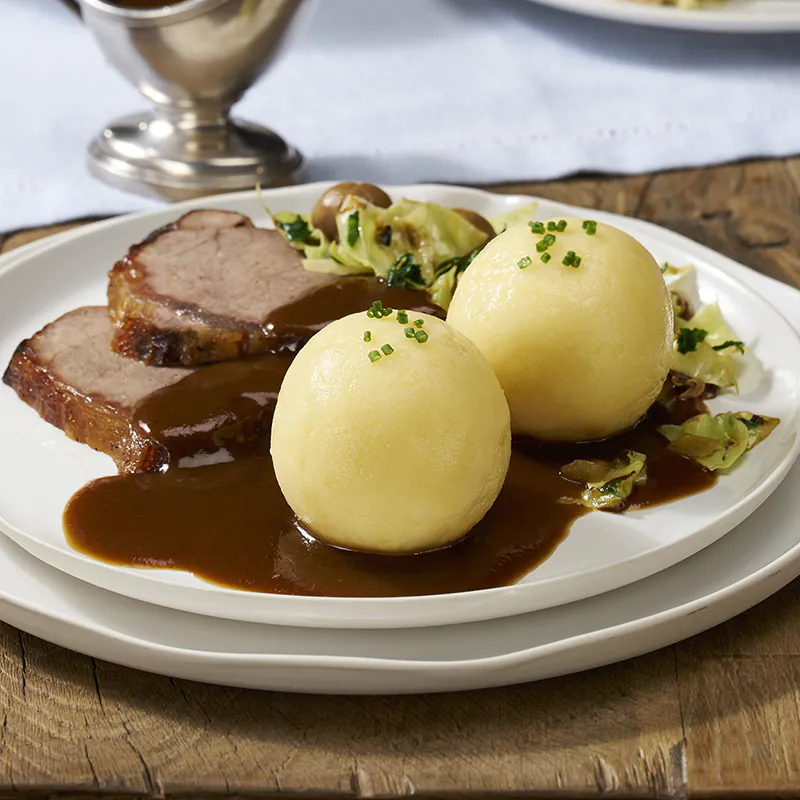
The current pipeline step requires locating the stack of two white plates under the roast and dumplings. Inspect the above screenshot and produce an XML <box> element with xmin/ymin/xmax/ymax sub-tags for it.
<box><xmin>0</xmin><ymin>185</ymin><xmax>800</xmax><ymax>693</ymax></box>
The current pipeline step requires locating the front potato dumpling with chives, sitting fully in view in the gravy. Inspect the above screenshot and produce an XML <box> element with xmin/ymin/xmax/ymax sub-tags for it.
<box><xmin>271</xmin><ymin>311</ymin><xmax>511</xmax><ymax>553</ymax></box>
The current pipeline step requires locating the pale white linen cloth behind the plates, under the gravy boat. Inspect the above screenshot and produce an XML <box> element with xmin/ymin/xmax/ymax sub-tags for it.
<box><xmin>0</xmin><ymin>0</ymin><xmax>800</xmax><ymax>230</ymax></box>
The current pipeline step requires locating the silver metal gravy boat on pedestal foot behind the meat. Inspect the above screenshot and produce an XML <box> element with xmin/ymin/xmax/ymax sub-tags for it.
<box><xmin>80</xmin><ymin>0</ymin><xmax>302</xmax><ymax>200</ymax></box>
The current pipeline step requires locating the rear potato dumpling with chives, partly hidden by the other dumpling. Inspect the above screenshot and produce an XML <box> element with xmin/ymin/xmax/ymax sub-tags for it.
<box><xmin>447</xmin><ymin>218</ymin><xmax>673</xmax><ymax>442</ymax></box>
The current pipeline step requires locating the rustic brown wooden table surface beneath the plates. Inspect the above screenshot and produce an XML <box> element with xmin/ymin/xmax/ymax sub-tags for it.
<box><xmin>0</xmin><ymin>159</ymin><xmax>800</xmax><ymax>798</ymax></box>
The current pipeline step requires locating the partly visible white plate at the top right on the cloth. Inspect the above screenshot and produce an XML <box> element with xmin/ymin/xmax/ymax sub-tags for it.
<box><xmin>520</xmin><ymin>0</ymin><xmax>800</xmax><ymax>33</ymax></box>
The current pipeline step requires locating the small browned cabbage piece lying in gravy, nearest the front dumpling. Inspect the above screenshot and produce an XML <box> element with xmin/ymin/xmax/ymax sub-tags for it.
<box><xmin>559</xmin><ymin>450</ymin><xmax>647</xmax><ymax>511</ymax></box>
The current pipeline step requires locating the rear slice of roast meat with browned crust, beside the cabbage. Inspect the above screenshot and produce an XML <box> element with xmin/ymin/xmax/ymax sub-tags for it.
<box><xmin>108</xmin><ymin>210</ymin><xmax>337</xmax><ymax>366</ymax></box>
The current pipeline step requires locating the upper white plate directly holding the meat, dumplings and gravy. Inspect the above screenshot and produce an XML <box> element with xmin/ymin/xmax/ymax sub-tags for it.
<box><xmin>0</xmin><ymin>184</ymin><xmax>800</xmax><ymax>628</ymax></box>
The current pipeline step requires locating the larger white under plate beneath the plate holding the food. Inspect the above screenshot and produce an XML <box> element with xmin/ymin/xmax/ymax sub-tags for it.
<box><xmin>0</xmin><ymin>258</ymin><xmax>800</xmax><ymax>694</ymax></box>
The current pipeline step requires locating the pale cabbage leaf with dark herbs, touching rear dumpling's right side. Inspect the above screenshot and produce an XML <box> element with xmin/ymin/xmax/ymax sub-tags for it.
<box><xmin>671</xmin><ymin>303</ymin><xmax>744</xmax><ymax>389</ymax></box>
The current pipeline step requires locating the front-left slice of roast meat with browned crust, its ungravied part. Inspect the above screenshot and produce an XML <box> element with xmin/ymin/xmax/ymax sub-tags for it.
<box><xmin>3</xmin><ymin>306</ymin><xmax>191</xmax><ymax>471</ymax></box>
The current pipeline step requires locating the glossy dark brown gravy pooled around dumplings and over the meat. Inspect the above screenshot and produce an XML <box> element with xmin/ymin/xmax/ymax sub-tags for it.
<box><xmin>64</xmin><ymin>279</ymin><xmax>715</xmax><ymax>597</ymax></box>
